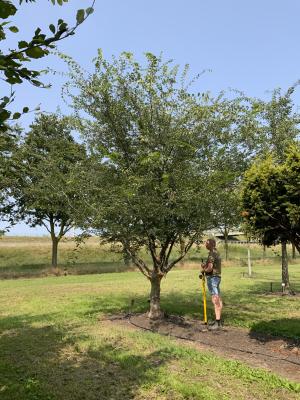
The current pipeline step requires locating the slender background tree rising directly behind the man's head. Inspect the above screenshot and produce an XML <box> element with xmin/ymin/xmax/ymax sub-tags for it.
<box><xmin>202</xmin><ymin>94</ymin><xmax>265</xmax><ymax>260</ymax></box>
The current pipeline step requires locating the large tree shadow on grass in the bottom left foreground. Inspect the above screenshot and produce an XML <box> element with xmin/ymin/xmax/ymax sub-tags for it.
<box><xmin>0</xmin><ymin>315</ymin><xmax>174</xmax><ymax>400</ymax></box>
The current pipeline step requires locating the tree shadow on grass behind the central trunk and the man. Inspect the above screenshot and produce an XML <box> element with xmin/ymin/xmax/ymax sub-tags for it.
<box><xmin>86</xmin><ymin>282</ymin><xmax>300</xmax><ymax>340</ymax></box>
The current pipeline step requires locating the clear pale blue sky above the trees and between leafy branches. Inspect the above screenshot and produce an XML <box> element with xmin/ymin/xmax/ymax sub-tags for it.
<box><xmin>1</xmin><ymin>0</ymin><xmax>300</xmax><ymax>235</ymax></box>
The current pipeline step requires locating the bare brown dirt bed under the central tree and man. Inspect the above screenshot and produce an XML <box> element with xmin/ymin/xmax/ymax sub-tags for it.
<box><xmin>110</xmin><ymin>314</ymin><xmax>300</xmax><ymax>383</ymax></box>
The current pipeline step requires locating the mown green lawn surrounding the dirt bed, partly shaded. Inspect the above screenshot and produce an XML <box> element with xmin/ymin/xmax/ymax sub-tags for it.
<box><xmin>0</xmin><ymin>265</ymin><xmax>300</xmax><ymax>400</ymax></box>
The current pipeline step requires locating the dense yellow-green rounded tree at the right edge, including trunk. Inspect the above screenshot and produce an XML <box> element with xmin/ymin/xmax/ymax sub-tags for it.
<box><xmin>242</xmin><ymin>143</ymin><xmax>300</xmax><ymax>290</ymax></box>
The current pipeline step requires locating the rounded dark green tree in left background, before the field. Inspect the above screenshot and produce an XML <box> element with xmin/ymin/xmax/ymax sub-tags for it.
<box><xmin>11</xmin><ymin>115</ymin><xmax>87</xmax><ymax>267</ymax></box>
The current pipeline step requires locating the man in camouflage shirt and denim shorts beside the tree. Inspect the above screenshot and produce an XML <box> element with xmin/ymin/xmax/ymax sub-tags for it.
<box><xmin>201</xmin><ymin>239</ymin><xmax>223</xmax><ymax>330</ymax></box>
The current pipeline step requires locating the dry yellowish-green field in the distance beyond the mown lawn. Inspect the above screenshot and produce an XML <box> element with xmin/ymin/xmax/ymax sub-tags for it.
<box><xmin>0</xmin><ymin>236</ymin><xmax>300</xmax><ymax>278</ymax></box>
